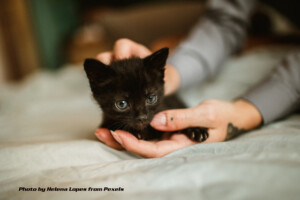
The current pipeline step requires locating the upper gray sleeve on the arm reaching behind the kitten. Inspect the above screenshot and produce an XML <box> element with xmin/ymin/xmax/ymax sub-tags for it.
<box><xmin>168</xmin><ymin>0</ymin><xmax>255</xmax><ymax>88</ymax></box>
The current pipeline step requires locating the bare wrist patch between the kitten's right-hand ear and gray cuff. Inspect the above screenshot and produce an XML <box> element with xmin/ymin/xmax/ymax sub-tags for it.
<box><xmin>165</xmin><ymin>65</ymin><xmax>180</xmax><ymax>95</ymax></box>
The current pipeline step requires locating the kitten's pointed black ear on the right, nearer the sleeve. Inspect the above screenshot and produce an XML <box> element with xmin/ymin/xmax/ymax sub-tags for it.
<box><xmin>144</xmin><ymin>48</ymin><xmax>169</xmax><ymax>71</ymax></box>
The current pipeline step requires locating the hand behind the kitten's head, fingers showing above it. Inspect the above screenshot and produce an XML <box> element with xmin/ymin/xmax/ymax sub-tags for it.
<box><xmin>97</xmin><ymin>38</ymin><xmax>180</xmax><ymax>95</ymax></box>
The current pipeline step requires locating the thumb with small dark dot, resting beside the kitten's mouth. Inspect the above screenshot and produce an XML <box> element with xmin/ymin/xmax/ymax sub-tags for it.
<box><xmin>150</xmin><ymin>108</ymin><xmax>199</xmax><ymax>131</ymax></box>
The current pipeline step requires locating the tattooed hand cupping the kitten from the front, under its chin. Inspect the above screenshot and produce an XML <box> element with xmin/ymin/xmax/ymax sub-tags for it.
<box><xmin>95</xmin><ymin>100</ymin><xmax>262</xmax><ymax>157</ymax></box>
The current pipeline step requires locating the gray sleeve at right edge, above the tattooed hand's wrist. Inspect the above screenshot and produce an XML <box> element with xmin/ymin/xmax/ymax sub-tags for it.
<box><xmin>242</xmin><ymin>51</ymin><xmax>300</xmax><ymax>124</ymax></box>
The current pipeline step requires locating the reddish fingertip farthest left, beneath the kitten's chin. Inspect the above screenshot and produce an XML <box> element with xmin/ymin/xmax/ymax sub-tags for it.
<box><xmin>95</xmin><ymin>128</ymin><xmax>124</xmax><ymax>150</ymax></box>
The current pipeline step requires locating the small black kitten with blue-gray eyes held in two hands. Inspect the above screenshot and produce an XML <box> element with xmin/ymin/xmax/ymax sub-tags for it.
<box><xmin>84</xmin><ymin>48</ymin><xmax>208</xmax><ymax>142</ymax></box>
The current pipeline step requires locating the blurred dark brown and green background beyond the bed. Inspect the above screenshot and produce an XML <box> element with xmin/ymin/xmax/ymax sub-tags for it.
<box><xmin>0</xmin><ymin>0</ymin><xmax>300</xmax><ymax>83</ymax></box>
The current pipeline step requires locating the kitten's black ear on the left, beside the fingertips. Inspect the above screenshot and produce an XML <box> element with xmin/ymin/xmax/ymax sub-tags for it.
<box><xmin>83</xmin><ymin>58</ymin><xmax>114</xmax><ymax>83</ymax></box>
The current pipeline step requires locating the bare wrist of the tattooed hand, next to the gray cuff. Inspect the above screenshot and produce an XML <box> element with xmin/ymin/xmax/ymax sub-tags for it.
<box><xmin>233</xmin><ymin>99</ymin><xmax>263</xmax><ymax>130</ymax></box>
